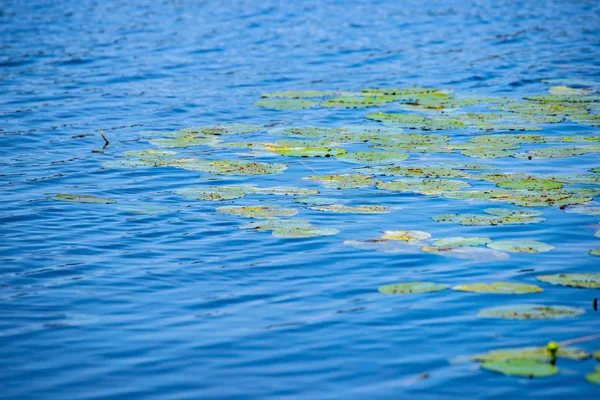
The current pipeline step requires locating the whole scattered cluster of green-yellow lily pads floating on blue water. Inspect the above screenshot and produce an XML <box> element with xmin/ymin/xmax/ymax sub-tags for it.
<box><xmin>49</xmin><ymin>81</ymin><xmax>600</xmax><ymax>383</ymax></box>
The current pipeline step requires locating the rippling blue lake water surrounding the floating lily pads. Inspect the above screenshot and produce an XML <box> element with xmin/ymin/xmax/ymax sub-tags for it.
<box><xmin>0</xmin><ymin>0</ymin><xmax>600</xmax><ymax>399</ymax></box>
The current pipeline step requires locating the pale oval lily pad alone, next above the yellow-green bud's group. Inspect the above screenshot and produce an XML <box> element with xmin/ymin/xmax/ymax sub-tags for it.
<box><xmin>478</xmin><ymin>304</ymin><xmax>585</xmax><ymax>319</ymax></box>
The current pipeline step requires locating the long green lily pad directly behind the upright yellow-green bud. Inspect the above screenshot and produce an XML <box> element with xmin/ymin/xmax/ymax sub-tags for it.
<box><xmin>471</xmin><ymin>346</ymin><xmax>590</xmax><ymax>362</ymax></box>
